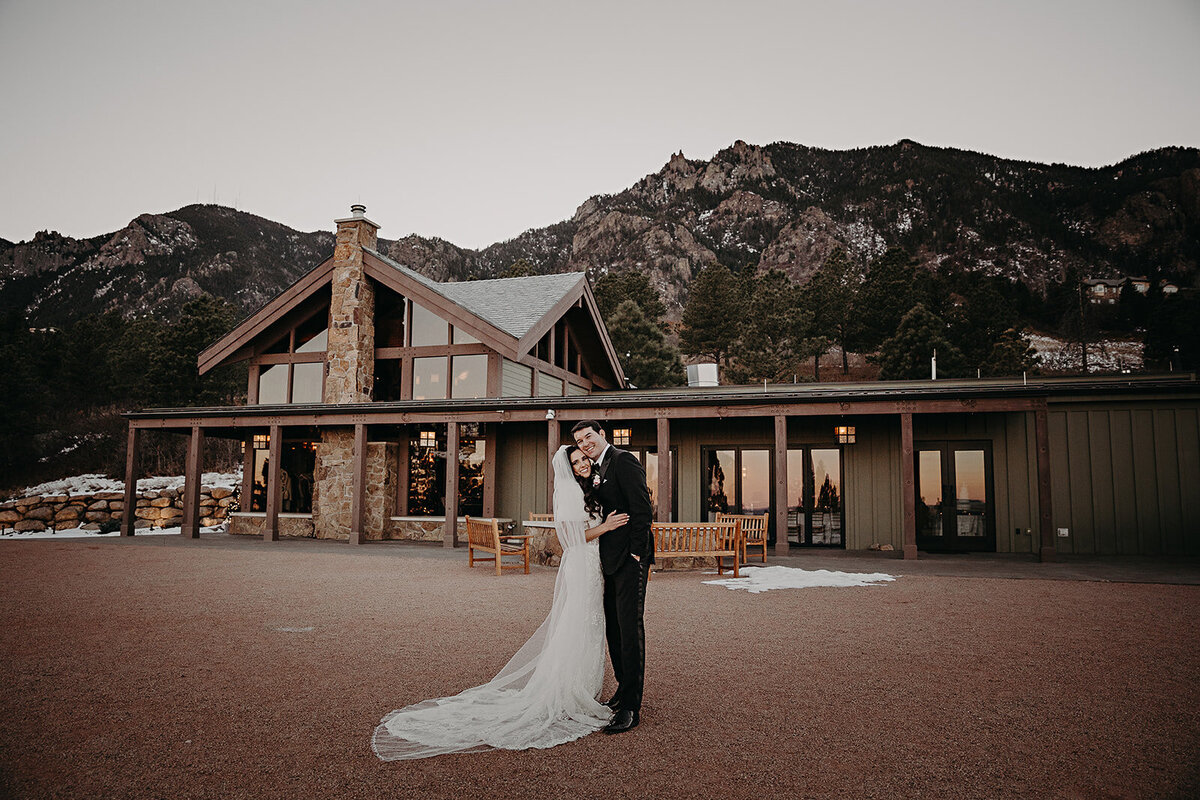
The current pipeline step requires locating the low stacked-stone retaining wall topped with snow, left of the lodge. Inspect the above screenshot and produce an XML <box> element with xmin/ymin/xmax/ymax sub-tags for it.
<box><xmin>0</xmin><ymin>486</ymin><xmax>236</xmax><ymax>531</ymax></box>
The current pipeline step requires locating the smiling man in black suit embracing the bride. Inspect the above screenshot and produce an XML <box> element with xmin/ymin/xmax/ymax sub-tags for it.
<box><xmin>571</xmin><ymin>420</ymin><xmax>654</xmax><ymax>733</ymax></box>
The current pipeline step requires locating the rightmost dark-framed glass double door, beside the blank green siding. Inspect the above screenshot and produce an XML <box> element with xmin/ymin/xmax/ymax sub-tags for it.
<box><xmin>914</xmin><ymin>441</ymin><xmax>996</xmax><ymax>553</ymax></box>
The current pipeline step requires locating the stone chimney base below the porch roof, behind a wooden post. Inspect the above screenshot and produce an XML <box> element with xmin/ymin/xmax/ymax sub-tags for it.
<box><xmin>312</xmin><ymin>431</ymin><xmax>398</xmax><ymax>540</ymax></box>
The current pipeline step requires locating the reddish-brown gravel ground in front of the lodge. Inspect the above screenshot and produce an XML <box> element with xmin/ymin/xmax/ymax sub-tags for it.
<box><xmin>0</xmin><ymin>535</ymin><xmax>1200</xmax><ymax>800</ymax></box>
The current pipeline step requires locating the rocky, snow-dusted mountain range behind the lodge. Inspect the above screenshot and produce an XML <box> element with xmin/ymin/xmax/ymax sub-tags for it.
<box><xmin>0</xmin><ymin>140</ymin><xmax>1200</xmax><ymax>325</ymax></box>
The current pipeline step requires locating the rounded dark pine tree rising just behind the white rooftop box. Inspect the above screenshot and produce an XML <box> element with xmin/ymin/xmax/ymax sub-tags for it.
<box><xmin>679</xmin><ymin>264</ymin><xmax>746</xmax><ymax>374</ymax></box>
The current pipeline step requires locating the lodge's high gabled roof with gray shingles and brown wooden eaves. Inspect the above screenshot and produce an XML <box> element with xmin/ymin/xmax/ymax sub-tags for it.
<box><xmin>198</xmin><ymin>248</ymin><xmax>625</xmax><ymax>386</ymax></box>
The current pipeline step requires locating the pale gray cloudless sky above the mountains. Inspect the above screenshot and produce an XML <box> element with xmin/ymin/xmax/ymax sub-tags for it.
<box><xmin>0</xmin><ymin>0</ymin><xmax>1200</xmax><ymax>247</ymax></box>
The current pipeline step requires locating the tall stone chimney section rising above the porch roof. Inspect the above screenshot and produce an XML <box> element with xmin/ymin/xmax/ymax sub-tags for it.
<box><xmin>325</xmin><ymin>204</ymin><xmax>379</xmax><ymax>403</ymax></box>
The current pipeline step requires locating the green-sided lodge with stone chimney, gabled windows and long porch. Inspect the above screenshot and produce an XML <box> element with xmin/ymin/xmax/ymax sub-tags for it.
<box><xmin>122</xmin><ymin>205</ymin><xmax>1200</xmax><ymax>559</ymax></box>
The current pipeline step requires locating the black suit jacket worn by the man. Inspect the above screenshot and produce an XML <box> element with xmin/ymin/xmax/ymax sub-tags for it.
<box><xmin>596</xmin><ymin>445</ymin><xmax>654</xmax><ymax>575</ymax></box>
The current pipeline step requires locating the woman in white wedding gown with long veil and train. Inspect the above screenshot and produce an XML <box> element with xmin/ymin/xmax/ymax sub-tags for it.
<box><xmin>371</xmin><ymin>445</ymin><xmax>629</xmax><ymax>762</ymax></box>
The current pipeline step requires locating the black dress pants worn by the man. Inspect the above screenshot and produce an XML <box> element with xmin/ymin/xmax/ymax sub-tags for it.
<box><xmin>604</xmin><ymin>555</ymin><xmax>650</xmax><ymax>711</ymax></box>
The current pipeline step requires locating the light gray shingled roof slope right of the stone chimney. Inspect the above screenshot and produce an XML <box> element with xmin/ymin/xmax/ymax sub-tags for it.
<box><xmin>370</xmin><ymin>251</ymin><xmax>586</xmax><ymax>338</ymax></box>
